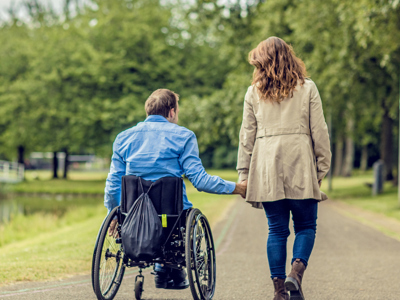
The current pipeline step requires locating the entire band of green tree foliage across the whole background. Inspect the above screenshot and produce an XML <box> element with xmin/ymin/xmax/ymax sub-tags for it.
<box><xmin>0</xmin><ymin>0</ymin><xmax>400</xmax><ymax>167</ymax></box>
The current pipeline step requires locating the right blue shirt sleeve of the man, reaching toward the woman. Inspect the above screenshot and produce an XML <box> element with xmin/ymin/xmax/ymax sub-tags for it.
<box><xmin>179</xmin><ymin>133</ymin><xmax>236</xmax><ymax>194</ymax></box>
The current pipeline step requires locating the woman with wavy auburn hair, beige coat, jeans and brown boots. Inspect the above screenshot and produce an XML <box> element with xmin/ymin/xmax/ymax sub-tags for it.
<box><xmin>237</xmin><ymin>37</ymin><xmax>331</xmax><ymax>300</ymax></box>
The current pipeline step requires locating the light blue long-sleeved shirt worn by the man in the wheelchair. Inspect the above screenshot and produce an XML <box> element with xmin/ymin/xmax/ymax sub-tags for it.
<box><xmin>104</xmin><ymin>115</ymin><xmax>235</xmax><ymax>212</ymax></box>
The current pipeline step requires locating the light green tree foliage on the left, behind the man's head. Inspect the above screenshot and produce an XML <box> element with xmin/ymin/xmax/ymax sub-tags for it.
<box><xmin>0</xmin><ymin>0</ymin><xmax>234</xmax><ymax>162</ymax></box>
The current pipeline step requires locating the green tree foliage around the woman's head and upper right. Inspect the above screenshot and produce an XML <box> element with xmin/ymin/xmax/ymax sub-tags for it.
<box><xmin>191</xmin><ymin>0</ymin><xmax>400</xmax><ymax>169</ymax></box>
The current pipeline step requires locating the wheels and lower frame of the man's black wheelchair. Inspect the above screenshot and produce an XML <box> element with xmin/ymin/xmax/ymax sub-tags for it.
<box><xmin>92</xmin><ymin>206</ymin><xmax>216</xmax><ymax>300</ymax></box>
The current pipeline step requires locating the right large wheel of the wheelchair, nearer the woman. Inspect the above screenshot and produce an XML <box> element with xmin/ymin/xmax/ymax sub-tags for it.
<box><xmin>185</xmin><ymin>209</ymin><xmax>216</xmax><ymax>300</ymax></box>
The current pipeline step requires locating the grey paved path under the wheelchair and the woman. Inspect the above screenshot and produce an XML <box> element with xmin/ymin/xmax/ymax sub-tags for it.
<box><xmin>0</xmin><ymin>201</ymin><xmax>400</xmax><ymax>300</ymax></box>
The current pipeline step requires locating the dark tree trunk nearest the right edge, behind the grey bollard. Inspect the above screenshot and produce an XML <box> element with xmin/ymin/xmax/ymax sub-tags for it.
<box><xmin>381</xmin><ymin>108</ymin><xmax>393</xmax><ymax>180</ymax></box>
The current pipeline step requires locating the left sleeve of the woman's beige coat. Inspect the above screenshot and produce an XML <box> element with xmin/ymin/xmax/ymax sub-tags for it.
<box><xmin>236</xmin><ymin>87</ymin><xmax>257</xmax><ymax>181</ymax></box>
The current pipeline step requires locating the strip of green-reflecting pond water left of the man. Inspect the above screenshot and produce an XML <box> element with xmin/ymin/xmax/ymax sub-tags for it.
<box><xmin>0</xmin><ymin>195</ymin><xmax>103</xmax><ymax>224</ymax></box>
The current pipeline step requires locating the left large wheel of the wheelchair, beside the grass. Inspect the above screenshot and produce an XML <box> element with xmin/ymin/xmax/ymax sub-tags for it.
<box><xmin>92</xmin><ymin>207</ymin><xmax>125</xmax><ymax>300</ymax></box>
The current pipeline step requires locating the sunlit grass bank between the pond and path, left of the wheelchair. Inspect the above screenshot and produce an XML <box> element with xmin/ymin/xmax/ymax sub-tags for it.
<box><xmin>0</xmin><ymin>207</ymin><xmax>104</xmax><ymax>285</ymax></box>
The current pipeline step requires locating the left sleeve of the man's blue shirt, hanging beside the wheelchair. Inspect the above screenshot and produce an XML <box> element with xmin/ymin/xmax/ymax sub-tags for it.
<box><xmin>104</xmin><ymin>137</ymin><xmax>126</xmax><ymax>213</ymax></box>
